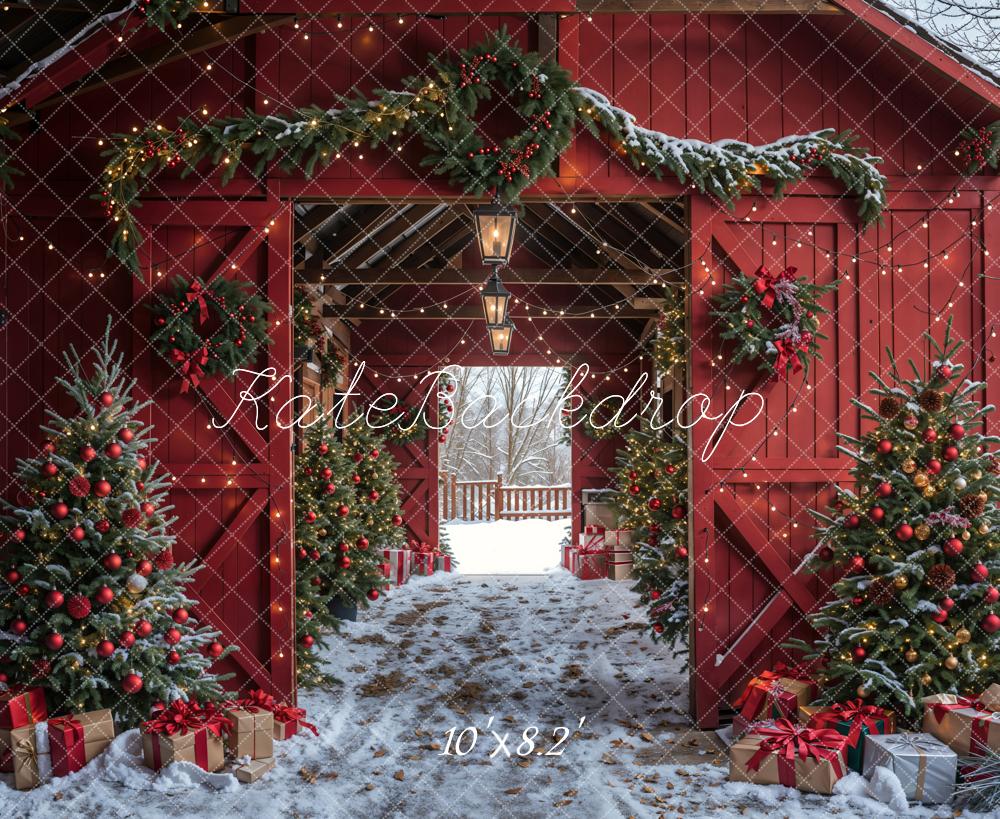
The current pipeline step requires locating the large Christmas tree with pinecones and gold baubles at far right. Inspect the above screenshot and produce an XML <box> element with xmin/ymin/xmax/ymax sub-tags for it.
<box><xmin>795</xmin><ymin>322</ymin><xmax>1000</xmax><ymax>716</ymax></box>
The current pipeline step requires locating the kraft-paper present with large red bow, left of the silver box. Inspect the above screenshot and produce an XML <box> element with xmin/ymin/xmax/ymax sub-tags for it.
<box><xmin>729</xmin><ymin>719</ymin><xmax>847</xmax><ymax>795</ymax></box>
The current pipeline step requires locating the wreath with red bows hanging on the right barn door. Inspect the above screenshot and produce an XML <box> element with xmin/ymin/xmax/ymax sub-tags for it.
<box><xmin>712</xmin><ymin>267</ymin><xmax>837</xmax><ymax>379</ymax></box>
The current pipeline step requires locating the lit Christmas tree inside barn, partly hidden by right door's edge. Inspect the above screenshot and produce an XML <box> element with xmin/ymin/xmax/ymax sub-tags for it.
<box><xmin>615</xmin><ymin>430</ymin><xmax>689</xmax><ymax>653</ymax></box>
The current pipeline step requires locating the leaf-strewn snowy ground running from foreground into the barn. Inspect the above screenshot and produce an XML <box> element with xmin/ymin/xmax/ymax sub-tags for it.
<box><xmin>0</xmin><ymin>570</ymin><xmax>964</xmax><ymax>819</ymax></box>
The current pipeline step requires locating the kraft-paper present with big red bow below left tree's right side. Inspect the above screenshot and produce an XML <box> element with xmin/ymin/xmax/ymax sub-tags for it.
<box><xmin>142</xmin><ymin>700</ymin><xmax>233</xmax><ymax>771</ymax></box>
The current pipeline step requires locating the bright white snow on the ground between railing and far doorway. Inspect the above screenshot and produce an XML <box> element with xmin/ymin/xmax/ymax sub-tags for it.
<box><xmin>443</xmin><ymin>518</ymin><xmax>569</xmax><ymax>574</ymax></box>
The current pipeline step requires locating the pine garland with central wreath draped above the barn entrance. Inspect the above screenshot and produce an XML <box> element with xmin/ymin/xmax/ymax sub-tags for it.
<box><xmin>95</xmin><ymin>30</ymin><xmax>886</xmax><ymax>275</ymax></box>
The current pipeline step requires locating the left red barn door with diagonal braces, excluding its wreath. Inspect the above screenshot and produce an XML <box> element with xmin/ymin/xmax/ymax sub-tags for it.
<box><xmin>132</xmin><ymin>201</ymin><xmax>295</xmax><ymax>697</ymax></box>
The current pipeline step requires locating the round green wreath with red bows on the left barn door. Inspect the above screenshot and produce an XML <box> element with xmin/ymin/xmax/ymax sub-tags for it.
<box><xmin>152</xmin><ymin>276</ymin><xmax>271</xmax><ymax>392</ymax></box>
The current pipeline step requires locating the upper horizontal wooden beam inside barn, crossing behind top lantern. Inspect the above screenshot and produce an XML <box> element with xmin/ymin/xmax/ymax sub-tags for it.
<box><xmin>298</xmin><ymin>267</ymin><xmax>677</xmax><ymax>287</ymax></box>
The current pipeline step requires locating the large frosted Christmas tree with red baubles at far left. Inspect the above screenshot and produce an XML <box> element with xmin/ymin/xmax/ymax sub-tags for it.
<box><xmin>0</xmin><ymin>321</ymin><xmax>232</xmax><ymax>725</ymax></box>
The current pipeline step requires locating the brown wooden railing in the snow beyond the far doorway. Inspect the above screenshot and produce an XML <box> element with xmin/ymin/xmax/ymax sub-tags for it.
<box><xmin>438</xmin><ymin>473</ymin><xmax>571</xmax><ymax>520</ymax></box>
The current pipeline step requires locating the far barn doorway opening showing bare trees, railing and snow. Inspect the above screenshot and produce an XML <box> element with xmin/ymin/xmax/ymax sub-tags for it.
<box><xmin>438</xmin><ymin>366</ymin><xmax>572</xmax><ymax>575</ymax></box>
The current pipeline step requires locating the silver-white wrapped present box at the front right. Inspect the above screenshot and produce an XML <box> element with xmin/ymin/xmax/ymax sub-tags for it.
<box><xmin>862</xmin><ymin>734</ymin><xmax>958</xmax><ymax>805</ymax></box>
